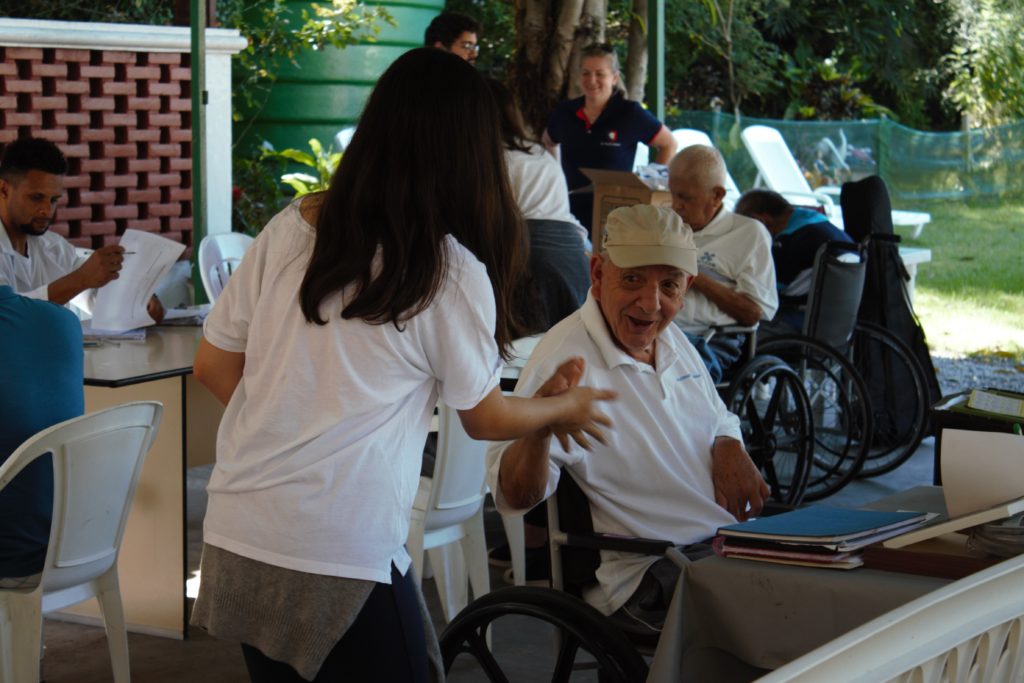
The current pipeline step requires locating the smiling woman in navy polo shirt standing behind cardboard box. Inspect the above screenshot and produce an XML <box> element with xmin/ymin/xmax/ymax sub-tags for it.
<box><xmin>544</xmin><ymin>44</ymin><xmax>676</xmax><ymax>237</ymax></box>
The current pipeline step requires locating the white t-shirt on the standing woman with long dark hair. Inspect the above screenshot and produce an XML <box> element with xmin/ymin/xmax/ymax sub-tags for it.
<box><xmin>204</xmin><ymin>204</ymin><xmax>501</xmax><ymax>584</ymax></box>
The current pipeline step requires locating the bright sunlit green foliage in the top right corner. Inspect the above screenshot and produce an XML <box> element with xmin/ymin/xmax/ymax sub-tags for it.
<box><xmin>944</xmin><ymin>0</ymin><xmax>1024</xmax><ymax>126</ymax></box>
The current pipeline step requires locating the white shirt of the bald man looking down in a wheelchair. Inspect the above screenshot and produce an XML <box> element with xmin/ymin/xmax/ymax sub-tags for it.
<box><xmin>676</xmin><ymin>208</ymin><xmax>778</xmax><ymax>334</ymax></box>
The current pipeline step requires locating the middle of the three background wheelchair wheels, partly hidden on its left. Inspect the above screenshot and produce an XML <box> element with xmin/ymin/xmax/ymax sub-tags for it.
<box><xmin>758</xmin><ymin>336</ymin><xmax>872</xmax><ymax>501</ymax></box>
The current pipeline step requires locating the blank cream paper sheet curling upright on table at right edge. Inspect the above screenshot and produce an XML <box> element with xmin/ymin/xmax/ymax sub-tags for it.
<box><xmin>942</xmin><ymin>429</ymin><xmax>1024</xmax><ymax>517</ymax></box>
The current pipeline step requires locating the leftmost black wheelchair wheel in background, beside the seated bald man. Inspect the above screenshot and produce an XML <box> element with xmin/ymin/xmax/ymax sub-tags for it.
<box><xmin>725</xmin><ymin>355</ymin><xmax>814</xmax><ymax>506</ymax></box>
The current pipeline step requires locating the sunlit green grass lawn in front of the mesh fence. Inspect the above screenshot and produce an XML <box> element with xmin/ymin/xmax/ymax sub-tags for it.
<box><xmin>897</xmin><ymin>198</ymin><xmax>1024</xmax><ymax>358</ymax></box>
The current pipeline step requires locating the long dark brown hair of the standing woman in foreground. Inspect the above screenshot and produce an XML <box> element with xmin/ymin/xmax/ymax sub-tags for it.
<box><xmin>299</xmin><ymin>48</ymin><xmax>527</xmax><ymax>355</ymax></box>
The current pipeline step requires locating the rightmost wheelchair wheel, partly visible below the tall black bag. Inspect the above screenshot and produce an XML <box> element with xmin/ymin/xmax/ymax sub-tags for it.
<box><xmin>853</xmin><ymin>323</ymin><xmax>928</xmax><ymax>477</ymax></box>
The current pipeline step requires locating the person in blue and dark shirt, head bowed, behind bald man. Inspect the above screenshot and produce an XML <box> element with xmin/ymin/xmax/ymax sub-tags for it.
<box><xmin>733</xmin><ymin>189</ymin><xmax>853</xmax><ymax>336</ymax></box>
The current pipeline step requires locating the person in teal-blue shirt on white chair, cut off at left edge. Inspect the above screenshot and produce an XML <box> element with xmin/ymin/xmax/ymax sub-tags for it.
<box><xmin>0</xmin><ymin>281</ymin><xmax>85</xmax><ymax>588</ymax></box>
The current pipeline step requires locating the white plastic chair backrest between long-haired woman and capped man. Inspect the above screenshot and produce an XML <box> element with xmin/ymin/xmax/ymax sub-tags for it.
<box><xmin>424</xmin><ymin>403</ymin><xmax>487</xmax><ymax>531</ymax></box>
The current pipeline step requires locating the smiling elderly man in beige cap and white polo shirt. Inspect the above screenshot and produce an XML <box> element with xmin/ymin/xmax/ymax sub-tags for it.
<box><xmin>487</xmin><ymin>205</ymin><xmax>768</xmax><ymax>632</ymax></box>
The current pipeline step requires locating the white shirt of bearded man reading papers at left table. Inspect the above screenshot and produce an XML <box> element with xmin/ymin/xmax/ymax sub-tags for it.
<box><xmin>0</xmin><ymin>222</ymin><xmax>84</xmax><ymax>301</ymax></box>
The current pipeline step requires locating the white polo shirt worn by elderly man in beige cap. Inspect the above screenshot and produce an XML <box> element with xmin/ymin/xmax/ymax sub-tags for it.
<box><xmin>487</xmin><ymin>295</ymin><xmax>740</xmax><ymax>614</ymax></box>
